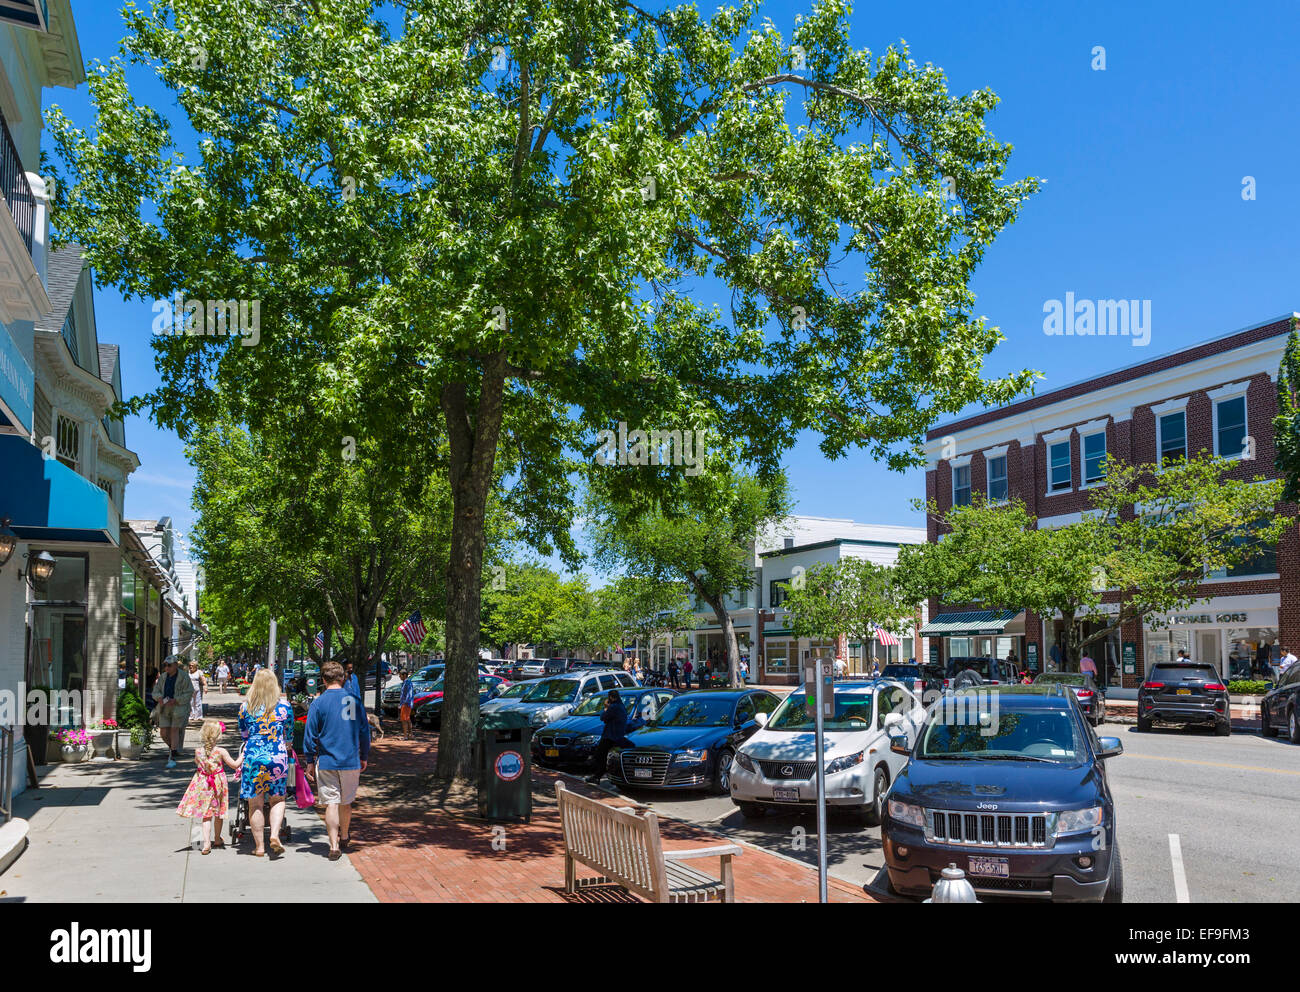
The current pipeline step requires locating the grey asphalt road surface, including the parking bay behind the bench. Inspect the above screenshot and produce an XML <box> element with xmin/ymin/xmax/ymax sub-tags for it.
<box><xmin>587</xmin><ymin>724</ymin><xmax>1300</xmax><ymax>902</ymax></box>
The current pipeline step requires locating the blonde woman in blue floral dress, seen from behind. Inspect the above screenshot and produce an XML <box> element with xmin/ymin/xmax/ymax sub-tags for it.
<box><xmin>239</xmin><ymin>668</ymin><xmax>294</xmax><ymax>858</ymax></box>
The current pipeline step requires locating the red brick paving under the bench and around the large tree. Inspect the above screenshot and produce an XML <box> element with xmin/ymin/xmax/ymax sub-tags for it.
<box><xmin>332</xmin><ymin>733</ymin><xmax>875</xmax><ymax>904</ymax></box>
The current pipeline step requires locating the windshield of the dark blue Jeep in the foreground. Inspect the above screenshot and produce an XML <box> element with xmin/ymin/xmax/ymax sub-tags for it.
<box><xmin>915</xmin><ymin>693</ymin><xmax>1084</xmax><ymax>764</ymax></box>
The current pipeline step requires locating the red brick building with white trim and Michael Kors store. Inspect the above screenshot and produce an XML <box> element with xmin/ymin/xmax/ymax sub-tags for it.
<box><xmin>922</xmin><ymin>315</ymin><xmax>1300</xmax><ymax>688</ymax></box>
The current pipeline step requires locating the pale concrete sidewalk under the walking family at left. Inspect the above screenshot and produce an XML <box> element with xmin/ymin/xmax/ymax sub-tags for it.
<box><xmin>0</xmin><ymin>693</ymin><xmax>377</xmax><ymax>902</ymax></box>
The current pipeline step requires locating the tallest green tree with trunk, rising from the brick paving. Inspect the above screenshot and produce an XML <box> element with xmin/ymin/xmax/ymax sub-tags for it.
<box><xmin>47</xmin><ymin>0</ymin><xmax>1037</xmax><ymax>775</ymax></box>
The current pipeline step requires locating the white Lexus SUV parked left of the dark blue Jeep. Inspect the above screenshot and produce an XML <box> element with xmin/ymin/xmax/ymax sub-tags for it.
<box><xmin>731</xmin><ymin>679</ymin><xmax>926</xmax><ymax>824</ymax></box>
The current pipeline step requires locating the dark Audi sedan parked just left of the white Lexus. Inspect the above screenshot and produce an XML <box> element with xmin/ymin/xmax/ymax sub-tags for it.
<box><xmin>607</xmin><ymin>689</ymin><xmax>780</xmax><ymax>794</ymax></box>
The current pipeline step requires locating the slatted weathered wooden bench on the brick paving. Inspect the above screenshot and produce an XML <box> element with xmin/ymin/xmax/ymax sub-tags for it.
<box><xmin>555</xmin><ymin>781</ymin><xmax>742</xmax><ymax>902</ymax></box>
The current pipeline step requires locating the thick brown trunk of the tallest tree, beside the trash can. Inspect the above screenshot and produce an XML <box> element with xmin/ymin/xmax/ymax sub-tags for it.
<box><xmin>438</xmin><ymin>352</ymin><xmax>506</xmax><ymax>779</ymax></box>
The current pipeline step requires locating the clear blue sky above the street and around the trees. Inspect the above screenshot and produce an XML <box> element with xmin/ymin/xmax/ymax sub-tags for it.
<box><xmin>55</xmin><ymin>0</ymin><xmax>1300</xmax><ymax>551</ymax></box>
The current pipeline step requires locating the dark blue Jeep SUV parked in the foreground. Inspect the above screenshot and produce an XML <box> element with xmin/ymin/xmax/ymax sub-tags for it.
<box><xmin>880</xmin><ymin>685</ymin><xmax>1125</xmax><ymax>902</ymax></box>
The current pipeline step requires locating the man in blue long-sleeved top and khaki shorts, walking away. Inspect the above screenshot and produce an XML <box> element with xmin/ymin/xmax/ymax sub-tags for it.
<box><xmin>303</xmin><ymin>662</ymin><xmax>371</xmax><ymax>861</ymax></box>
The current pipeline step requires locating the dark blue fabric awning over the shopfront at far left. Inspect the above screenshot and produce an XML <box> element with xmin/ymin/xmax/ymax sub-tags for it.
<box><xmin>0</xmin><ymin>434</ymin><xmax>121</xmax><ymax>545</ymax></box>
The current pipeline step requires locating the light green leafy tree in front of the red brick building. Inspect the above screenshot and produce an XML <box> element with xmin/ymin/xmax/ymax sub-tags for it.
<box><xmin>897</xmin><ymin>455</ymin><xmax>1288</xmax><ymax>667</ymax></box>
